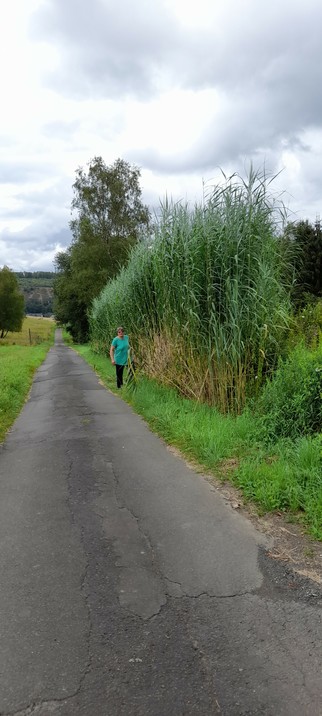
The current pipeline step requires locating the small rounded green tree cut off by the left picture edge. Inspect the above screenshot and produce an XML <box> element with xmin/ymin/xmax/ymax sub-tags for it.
<box><xmin>0</xmin><ymin>266</ymin><xmax>24</xmax><ymax>338</ymax></box>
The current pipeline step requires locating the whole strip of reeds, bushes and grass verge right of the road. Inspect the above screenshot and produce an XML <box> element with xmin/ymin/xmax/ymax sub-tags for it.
<box><xmin>85</xmin><ymin>166</ymin><xmax>322</xmax><ymax>539</ymax></box>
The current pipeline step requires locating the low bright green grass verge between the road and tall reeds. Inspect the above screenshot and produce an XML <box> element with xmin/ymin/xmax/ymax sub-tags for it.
<box><xmin>75</xmin><ymin>345</ymin><xmax>322</xmax><ymax>540</ymax></box>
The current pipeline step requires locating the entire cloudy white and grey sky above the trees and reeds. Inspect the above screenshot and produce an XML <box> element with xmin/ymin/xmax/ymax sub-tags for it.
<box><xmin>0</xmin><ymin>0</ymin><xmax>322</xmax><ymax>271</ymax></box>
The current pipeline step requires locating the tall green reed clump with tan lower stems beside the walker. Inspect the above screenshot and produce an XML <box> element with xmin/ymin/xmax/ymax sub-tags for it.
<box><xmin>90</xmin><ymin>171</ymin><xmax>290</xmax><ymax>412</ymax></box>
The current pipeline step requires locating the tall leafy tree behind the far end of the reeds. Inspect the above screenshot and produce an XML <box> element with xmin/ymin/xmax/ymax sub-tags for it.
<box><xmin>54</xmin><ymin>157</ymin><xmax>150</xmax><ymax>341</ymax></box>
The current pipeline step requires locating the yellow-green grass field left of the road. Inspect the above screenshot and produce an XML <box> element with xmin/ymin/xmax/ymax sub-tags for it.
<box><xmin>0</xmin><ymin>318</ymin><xmax>56</xmax><ymax>442</ymax></box>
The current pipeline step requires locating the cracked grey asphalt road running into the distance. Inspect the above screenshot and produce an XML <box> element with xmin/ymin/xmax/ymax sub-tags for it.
<box><xmin>0</xmin><ymin>331</ymin><xmax>322</xmax><ymax>716</ymax></box>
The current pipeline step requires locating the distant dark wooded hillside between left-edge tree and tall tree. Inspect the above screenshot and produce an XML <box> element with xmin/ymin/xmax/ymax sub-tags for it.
<box><xmin>16</xmin><ymin>271</ymin><xmax>55</xmax><ymax>316</ymax></box>
